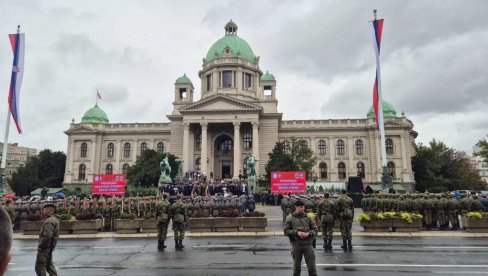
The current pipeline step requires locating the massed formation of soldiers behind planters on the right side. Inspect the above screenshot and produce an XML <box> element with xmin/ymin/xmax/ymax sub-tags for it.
<box><xmin>361</xmin><ymin>193</ymin><xmax>484</xmax><ymax>230</ymax></box>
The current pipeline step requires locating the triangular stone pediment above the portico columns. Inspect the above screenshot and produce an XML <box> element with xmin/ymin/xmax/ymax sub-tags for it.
<box><xmin>179</xmin><ymin>94</ymin><xmax>262</xmax><ymax>114</ymax></box>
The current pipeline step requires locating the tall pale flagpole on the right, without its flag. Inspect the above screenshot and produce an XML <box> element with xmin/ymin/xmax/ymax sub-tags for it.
<box><xmin>373</xmin><ymin>10</ymin><xmax>391</xmax><ymax>188</ymax></box>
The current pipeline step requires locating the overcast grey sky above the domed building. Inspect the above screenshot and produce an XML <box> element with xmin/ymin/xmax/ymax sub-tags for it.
<box><xmin>0</xmin><ymin>0</ymin><xmax>488</xmax><ymax>154</ymax></box>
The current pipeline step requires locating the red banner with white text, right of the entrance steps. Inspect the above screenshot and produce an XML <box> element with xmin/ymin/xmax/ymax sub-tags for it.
<box><xmin>271</xmin><ymin>172</ymin><xmax>307</xmax><ymax>194</ymax></box>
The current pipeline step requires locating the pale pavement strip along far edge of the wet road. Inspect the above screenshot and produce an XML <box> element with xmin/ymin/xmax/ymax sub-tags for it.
<box><xmin>14</xmin><ymin>205</ymin><xmax>488</xmax><ymax>240</ymax></box>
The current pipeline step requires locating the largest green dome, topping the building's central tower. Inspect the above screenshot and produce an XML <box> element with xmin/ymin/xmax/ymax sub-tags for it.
<box><xmin>205</xmin><ymin>20</ymin><xmax>256</xmax><ymax>62</ymax></box>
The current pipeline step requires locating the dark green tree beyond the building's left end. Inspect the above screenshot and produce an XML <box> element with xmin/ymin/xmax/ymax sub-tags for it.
<box><xmin>10</xmin><ymin>149</ymin><xmax>66</xmax><ymax>196</ymax></box>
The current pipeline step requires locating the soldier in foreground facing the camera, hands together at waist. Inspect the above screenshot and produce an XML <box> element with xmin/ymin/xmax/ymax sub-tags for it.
<box><xmin>284</xmin><ymin>200</ymin><xmax>317</xmax><ymax>276</ymax></box>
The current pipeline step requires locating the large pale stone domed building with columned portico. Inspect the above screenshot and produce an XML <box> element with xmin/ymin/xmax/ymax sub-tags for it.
<box><xmin>64</xmin><ymin>21</ymin><xmax>417</xmax><ymax>189</ymax></box>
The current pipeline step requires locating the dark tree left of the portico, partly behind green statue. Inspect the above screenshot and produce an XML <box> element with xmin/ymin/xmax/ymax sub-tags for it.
<box><xmin>127</xmin><ymin>149</ymin><xmax>181</xmax><ymax>187</ymax></box>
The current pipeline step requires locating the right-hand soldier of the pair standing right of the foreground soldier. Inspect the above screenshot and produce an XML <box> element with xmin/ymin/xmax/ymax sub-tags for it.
<box><xmin>336</xmin><ymin>189</ymin><xmax>354</xmax><ymax>250</ymax></box>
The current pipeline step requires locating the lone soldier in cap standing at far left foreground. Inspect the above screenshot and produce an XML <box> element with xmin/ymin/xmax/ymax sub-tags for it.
<box><xmin>36</xmin><ymin>203</ymin><xmax>59</xmax><ymax>276</ymax></box>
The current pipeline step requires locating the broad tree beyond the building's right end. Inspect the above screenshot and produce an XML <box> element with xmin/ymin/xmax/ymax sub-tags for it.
<box><xmin>412</xmin><ymin>139</ymin><xmax>484</xmax><ymax>192</ymax></box>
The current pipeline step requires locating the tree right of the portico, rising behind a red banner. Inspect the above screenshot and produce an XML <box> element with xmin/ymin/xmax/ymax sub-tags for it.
<box><xmin>265</xmin><ymin>138</ymin><xmax>317</xmax><ymax>179</ymax></box>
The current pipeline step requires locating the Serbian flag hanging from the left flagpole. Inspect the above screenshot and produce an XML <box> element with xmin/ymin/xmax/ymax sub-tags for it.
<box><xmin>8</xmin><ymin>30</ymin><xmax>25</xmax><ymax>133</ymax></box>
